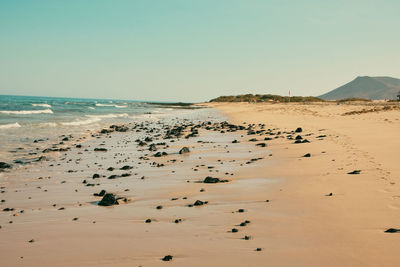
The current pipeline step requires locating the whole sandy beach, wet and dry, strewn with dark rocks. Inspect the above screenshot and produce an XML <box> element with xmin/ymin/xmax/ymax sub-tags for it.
<box><xmin>0</xmin><ymin>103</ymin><xmax>400</xmax><ymax>266</ymax></box>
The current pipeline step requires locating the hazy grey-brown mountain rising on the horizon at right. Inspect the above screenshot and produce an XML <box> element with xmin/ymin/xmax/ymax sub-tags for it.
<box><xmin>319</xmin><ymin>76</ymin><xmax>400</xmax><ymax>100</ymax></box>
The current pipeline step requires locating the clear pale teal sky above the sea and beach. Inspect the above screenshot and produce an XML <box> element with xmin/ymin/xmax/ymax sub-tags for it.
<box><xmin>0</xmin><ymin>0</ymin><xmax>400</xmax><ymax>101</ymax></box>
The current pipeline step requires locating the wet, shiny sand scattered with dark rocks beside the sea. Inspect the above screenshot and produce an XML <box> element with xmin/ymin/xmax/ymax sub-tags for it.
<box><xmin>0</xmin><ymin>111</ymin><xmax>275</xmax><ymax>266</ymax></box>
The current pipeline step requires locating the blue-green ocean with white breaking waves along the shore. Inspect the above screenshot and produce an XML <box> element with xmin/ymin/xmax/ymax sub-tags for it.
<box><xmin>0</xmin><ymin>95</ymin><xmax>200</xmax><ymax>161</ymax></box>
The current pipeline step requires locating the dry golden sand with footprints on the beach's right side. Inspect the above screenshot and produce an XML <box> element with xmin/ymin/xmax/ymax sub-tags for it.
<box><xmin>209</xmin><ymin>103</ymin><xmax>400</xmax><ymax>266</ymax></box>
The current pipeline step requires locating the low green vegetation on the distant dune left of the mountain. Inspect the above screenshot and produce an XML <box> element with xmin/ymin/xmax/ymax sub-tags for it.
<box><xmin>210</xmin><ymin>94</ymin><xmax>324</xmax><ymax>102</ymax></box>
